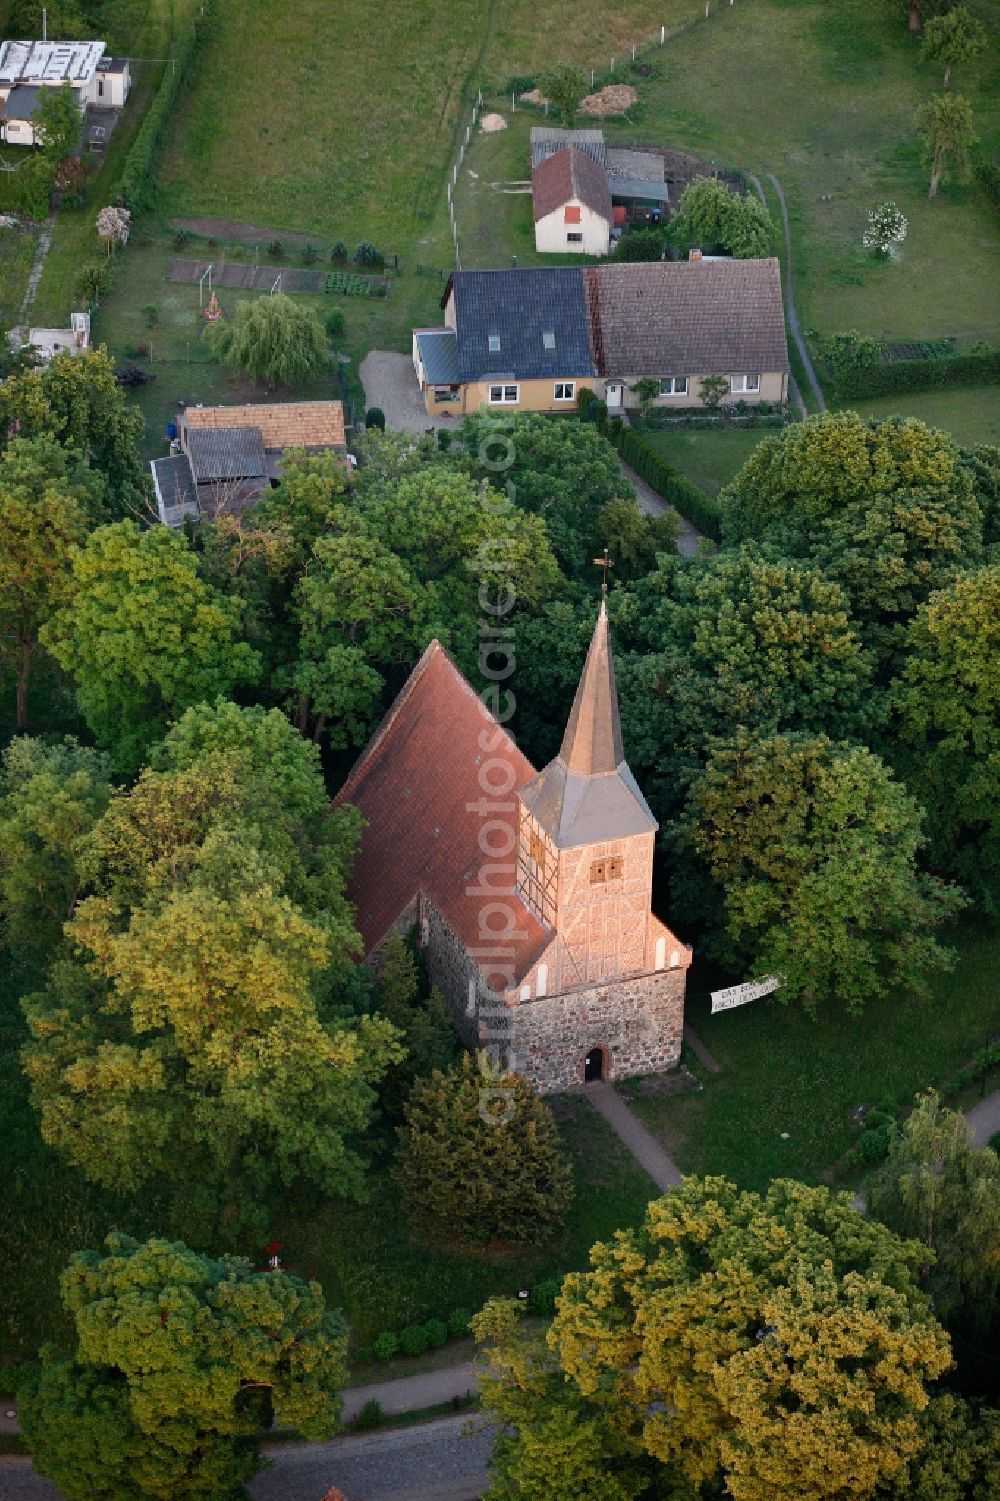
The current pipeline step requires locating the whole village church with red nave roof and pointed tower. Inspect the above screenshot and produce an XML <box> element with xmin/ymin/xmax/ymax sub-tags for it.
<box><xmin>336</xmin><ymin>602</ymin><xmax>692</xmax><ymax>1093</ymax></box>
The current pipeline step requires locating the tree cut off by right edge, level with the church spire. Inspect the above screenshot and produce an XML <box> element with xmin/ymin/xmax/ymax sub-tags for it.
<box><xmin>892</xmin><ymin>564</ymin><xmax>1000</xmax><ymax>907</ymax></box>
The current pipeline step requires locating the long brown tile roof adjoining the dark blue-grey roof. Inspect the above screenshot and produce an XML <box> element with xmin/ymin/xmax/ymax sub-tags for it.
<box><xmin>584</xmin><ymin>260</ymin><xmax>788</xmax><ymax>377</ymax></box>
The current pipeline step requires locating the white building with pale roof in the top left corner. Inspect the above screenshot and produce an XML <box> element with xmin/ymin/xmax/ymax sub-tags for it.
<box><xmin>0</xmin><ymin>42</ymin><xmax>132</xmax><ymax>146</ymax></box>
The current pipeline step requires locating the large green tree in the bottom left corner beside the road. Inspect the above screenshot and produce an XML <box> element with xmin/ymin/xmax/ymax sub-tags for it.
<box><xmin>20</xmin><ymin>1234</ymin><xmax>347</xmax><ymax>1501</ymax></box>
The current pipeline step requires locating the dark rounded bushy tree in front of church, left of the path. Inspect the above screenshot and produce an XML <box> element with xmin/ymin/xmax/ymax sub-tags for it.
<box><xmin>395</xmin><ymin>1054</ymin><xmax>574</xmax><ymax>1246</ymax></box>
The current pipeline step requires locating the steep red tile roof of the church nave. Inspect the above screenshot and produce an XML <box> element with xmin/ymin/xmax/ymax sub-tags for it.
<box><xmin>333</xmin><ymin>641</ymin><xmax>553</xmax><ymax>982</ymax></box>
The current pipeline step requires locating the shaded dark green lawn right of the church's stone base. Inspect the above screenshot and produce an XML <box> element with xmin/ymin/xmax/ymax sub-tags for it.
<box><xmin>626</xmin><ymin>922</ymin><xmax>1000</xmax><ymax>1189</ymax></box>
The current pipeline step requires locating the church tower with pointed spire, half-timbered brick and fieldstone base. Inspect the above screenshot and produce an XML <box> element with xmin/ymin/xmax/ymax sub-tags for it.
<box><xmin>514</xmin><ymin>599</ymin><xmax>691</xmax><ymax>1088</ymax></box>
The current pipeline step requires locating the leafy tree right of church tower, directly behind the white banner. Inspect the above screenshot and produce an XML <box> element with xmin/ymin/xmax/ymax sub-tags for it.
<box><xmin>679</xmin><ymin>731</ymin><xmax>962</xmax><ymax>1012</ymax></box>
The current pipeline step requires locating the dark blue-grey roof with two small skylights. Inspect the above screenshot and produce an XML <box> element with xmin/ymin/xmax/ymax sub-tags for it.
<box><xmin>444</xmin><ymin>266</ymin><xmax>596</xmax><ymax>383</ymax></box>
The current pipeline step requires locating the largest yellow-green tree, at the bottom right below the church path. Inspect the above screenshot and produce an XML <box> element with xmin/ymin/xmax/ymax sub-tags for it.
<box><xmin>474</xmin><ymin>1178</ymin><xmax>950</xmax><ymax>1501</ymax></box>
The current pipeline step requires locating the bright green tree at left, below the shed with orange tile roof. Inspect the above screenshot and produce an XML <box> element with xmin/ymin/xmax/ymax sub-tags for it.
<box><xmin>41</xmin><ymin>521</ymin><xmax>258</xmax><ymax>772</ymax></box>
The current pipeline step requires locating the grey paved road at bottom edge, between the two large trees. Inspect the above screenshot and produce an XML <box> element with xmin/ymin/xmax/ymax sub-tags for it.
<box><xmin>249</xmin><ymin>1415</ymin><xmax>492</xmax><ymax>1501</ymax></box>
